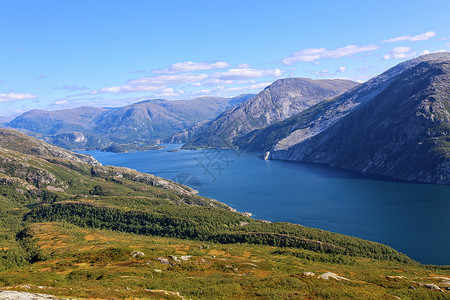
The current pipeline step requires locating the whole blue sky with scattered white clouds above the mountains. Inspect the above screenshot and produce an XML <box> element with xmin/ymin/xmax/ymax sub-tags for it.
<box><xmin>0</xmin><ymin>0</ymin><xmax>450</xmax><ymax>116</ymax></box>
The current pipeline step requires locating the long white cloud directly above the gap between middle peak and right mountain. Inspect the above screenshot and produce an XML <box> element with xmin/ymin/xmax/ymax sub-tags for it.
<box><xmin>281</xmin><ymin>45</ymin><xmax>380</xmax><ymax>65</ymax></box>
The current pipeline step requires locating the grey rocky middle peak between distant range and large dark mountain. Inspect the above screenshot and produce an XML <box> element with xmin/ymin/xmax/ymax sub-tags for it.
<box><xmin>185</xmin><ymin>78</ymin><xmax>357</xmax><ymax>148</ymax></box>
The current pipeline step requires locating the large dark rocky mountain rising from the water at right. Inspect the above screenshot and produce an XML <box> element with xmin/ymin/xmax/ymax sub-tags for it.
<box><xmin>238</xmin><ymin>53</ymin><xmax>450</xmax><ymax>184</ymax></box>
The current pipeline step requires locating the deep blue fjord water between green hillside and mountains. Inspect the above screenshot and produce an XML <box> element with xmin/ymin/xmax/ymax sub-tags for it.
<box><xmin>79</xmin><ymin>145</ymin><xmax>450</xmax><ymax>265</ymax></box>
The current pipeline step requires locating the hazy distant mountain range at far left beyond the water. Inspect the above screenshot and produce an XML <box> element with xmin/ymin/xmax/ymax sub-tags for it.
<box><xmin>6</xmin><ymin>95</ymin><xmax>253</xmax><ymax>149</ymax></box>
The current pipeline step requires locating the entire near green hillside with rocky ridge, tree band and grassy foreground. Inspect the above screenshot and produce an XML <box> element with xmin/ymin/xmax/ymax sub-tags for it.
<box><xmin>0</xmin><ymin>130</ymin><xmax>450</xmax><ymax>299</ymax></box>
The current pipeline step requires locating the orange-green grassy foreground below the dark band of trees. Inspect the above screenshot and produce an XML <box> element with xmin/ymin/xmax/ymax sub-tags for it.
<box><xmin>0</xmin><ymin>223</ymin><xmax>450</xmax><ymax>299</ymax></box>
